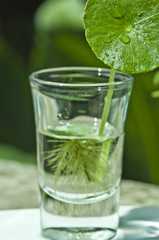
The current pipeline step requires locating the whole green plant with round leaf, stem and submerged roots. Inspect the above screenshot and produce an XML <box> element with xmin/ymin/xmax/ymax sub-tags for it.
<box><xmin>41</xmin><ymin>0</ymin><xmax>159</xmax><ymax>185</ymax></box>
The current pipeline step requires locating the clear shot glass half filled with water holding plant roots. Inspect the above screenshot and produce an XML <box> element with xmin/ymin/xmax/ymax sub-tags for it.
<box><xmin>30</xmin><ymin>67</ymin><xmax>133</xmax><ymax>240</ymax></box>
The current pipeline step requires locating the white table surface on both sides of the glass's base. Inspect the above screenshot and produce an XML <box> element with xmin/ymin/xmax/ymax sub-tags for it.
<box><xmin>0</xmin><ymin>206</ymin><xmax>159</xmax><ymax>240</ymax></box>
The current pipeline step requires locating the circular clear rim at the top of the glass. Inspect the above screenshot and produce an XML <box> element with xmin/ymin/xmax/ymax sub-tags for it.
<box><xmin>29</xmin><ymin>67</ymin><xmax>134</xmax><ymax>88</ymax></box>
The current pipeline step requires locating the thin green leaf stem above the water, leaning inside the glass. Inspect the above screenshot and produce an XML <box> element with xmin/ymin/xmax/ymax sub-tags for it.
<box><xmin>98</xmin><ymin>68</ymin><xmax>115</xmax><ymax>136</ymax></box>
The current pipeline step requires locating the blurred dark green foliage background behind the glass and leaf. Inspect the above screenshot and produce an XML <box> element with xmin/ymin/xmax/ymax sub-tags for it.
<box><xmin>0</xmin><ymin>0</ymin><xmax>159</xmax><ymax>184</ymax></box>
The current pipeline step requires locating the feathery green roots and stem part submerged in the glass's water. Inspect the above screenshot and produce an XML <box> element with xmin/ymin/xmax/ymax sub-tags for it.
<box><xmin>42</xmin><ymin>125</ymin><xmax>114</xmax><ymax>183</ymax></box>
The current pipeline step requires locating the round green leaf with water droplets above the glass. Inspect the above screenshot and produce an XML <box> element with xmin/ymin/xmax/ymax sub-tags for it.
<box><xmin>84</xmin><ymin>0</ymin><xmax>159</xmax><ymax>73</ymax></box>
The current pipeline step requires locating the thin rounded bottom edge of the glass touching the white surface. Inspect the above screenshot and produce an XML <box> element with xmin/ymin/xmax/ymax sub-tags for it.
<box><xmin>42</xmin><ymin>228</ymin><xmax>116</xmax><ymax>240</ymax></box>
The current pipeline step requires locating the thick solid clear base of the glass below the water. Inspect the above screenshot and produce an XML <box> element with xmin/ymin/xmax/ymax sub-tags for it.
<box><xmin>40</xmin><ymin>189</ymin><xmax>119</xmax><ymax>240</ymax></box>
